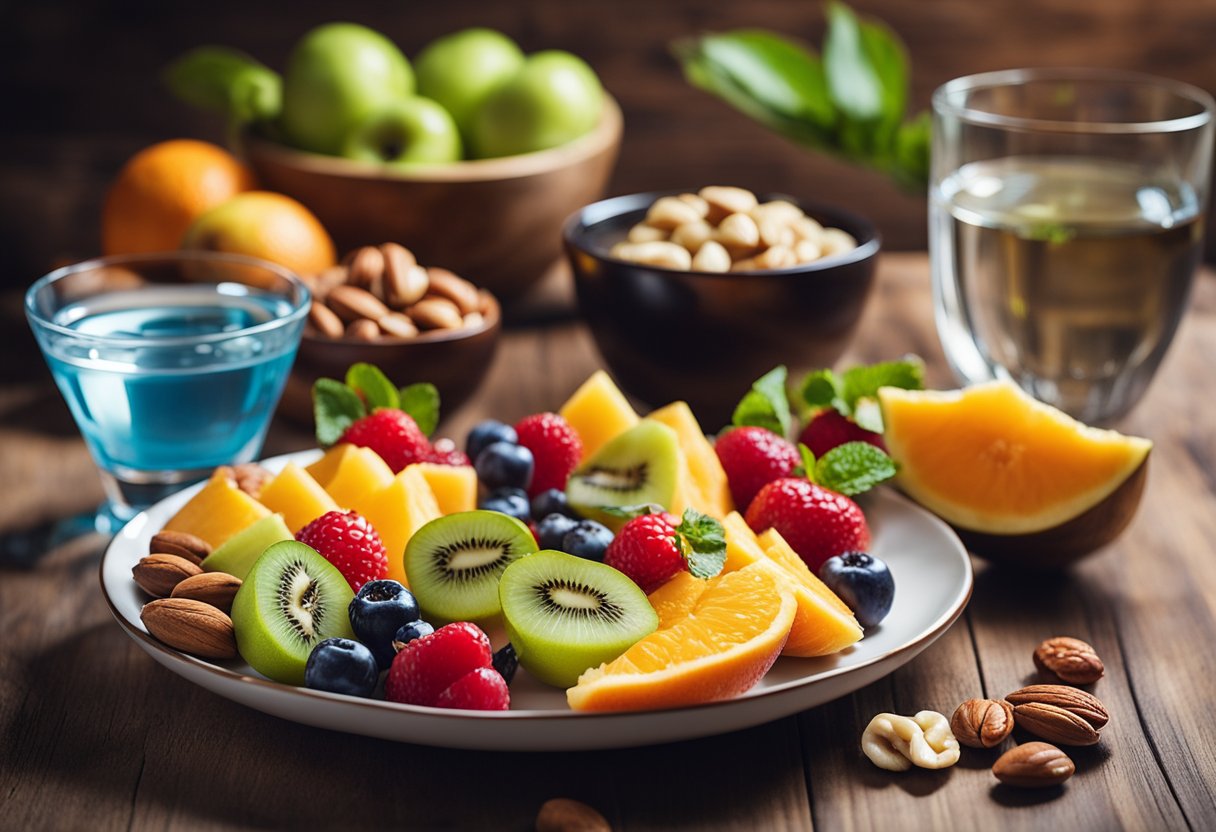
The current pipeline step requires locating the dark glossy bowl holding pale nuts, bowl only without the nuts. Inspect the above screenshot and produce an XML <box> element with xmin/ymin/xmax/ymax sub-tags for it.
<box><xmin>563</xmin><ymin>191</ymin><xmax>880</xmax><ymax>431</ymax></box>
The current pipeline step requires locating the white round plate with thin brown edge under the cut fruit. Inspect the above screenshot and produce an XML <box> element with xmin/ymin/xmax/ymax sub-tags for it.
<box><xmin>101</xmin><ymin>451</ymin><xmax>972</xmax><ymax>751</ymax></box>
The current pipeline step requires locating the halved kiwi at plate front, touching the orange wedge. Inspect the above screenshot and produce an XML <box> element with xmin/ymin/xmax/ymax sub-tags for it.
<box><xmin>499</xmin><ymin>549</ymin><xmax>659</xmax><ymax>687</ymax></box>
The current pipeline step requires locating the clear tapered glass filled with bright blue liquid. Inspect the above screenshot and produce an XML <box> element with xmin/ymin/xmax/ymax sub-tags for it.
<box><xmin>26</xmin><ymin>252</ymin><xmax>309</xmax><ymax>532</ymax></box>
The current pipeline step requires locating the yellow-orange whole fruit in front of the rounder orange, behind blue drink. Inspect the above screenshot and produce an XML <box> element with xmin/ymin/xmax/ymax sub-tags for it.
<box><xmin>181</xmin><ymin>191</ymin><xmax>334</xmax><ymax>275</ymax></box>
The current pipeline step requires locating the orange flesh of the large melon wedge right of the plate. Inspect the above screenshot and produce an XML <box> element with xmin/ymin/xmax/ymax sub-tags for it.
<box><xmin>878</xmin><ymin>381</ymin><xmax>1153</xmax><ymax>535</ymax></box>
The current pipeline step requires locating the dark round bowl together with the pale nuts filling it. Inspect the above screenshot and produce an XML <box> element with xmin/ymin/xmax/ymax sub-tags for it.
<box><xmin>564</xmin><ymin>186</ymin><xmax>880</xmax><ymax>429</ymax></box>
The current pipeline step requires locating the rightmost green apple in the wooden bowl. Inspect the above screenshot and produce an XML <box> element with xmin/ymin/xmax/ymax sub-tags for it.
<box><xmin>468</xmin><ymin>50</ymin><xmax>604</xmax><ymax>158</ymax></box>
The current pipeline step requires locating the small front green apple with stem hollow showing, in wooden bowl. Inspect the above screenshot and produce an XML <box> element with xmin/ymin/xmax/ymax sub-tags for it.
<box><xmin>342</xmin><ymin>95</ymin><xmax>462</xmax><ymax>164</ymax></box>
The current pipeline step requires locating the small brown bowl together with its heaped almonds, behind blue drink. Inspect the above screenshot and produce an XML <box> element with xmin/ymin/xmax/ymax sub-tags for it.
<box><xmin>278</xmin><ymin>242</ymin><xmax>502</xmax><ymax>426</ymax></box>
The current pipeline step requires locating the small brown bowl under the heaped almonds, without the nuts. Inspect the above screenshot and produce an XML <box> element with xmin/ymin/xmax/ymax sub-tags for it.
<box><xmin>278</xmin><ymin>289</ymin><xmax>502</xmax><ymax>427</ymax></box>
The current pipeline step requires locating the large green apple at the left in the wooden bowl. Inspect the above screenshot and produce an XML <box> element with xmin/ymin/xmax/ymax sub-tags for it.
<box><xmin>282</xmin><ymin>23</ymin><xmax>413</xmax><ymax>154</ymax></box>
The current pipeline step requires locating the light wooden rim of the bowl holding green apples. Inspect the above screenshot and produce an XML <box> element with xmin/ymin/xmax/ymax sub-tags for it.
<box><xmin>235</xmin><ymin>91</ymin><xmax>624</xmax><ymax>182</ymax></box>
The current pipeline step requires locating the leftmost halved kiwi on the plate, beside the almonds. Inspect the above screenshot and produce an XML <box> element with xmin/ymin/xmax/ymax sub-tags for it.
<box><xmin>232</xmin><ymin>540</ymin><xmax>355</xmax><ymax>685</ymax></box>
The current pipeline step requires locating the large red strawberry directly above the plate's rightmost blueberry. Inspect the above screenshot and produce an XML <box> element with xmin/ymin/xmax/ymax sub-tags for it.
<box><xmin>747</xmin><ymin>478</ymin><xmax>869</xmax><ymax>572</ymax></box>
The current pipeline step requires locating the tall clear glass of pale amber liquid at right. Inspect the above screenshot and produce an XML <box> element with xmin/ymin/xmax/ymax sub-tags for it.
<box><xmin>929</xmin><ymin>69</ymin><xmax>1214</xmax><ymax>423</ymax></box>
